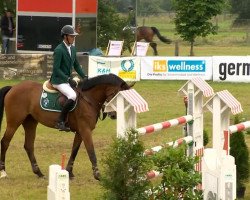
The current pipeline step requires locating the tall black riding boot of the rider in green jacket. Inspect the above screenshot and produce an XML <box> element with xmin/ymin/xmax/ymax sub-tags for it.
<box><xmin>56</xmin><ymin>99</ymin><xmax>74</xmax><ymax>132</ymax></box>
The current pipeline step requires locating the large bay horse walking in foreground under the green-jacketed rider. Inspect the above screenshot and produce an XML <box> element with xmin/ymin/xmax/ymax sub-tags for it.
<box><xmin>0</xmin><ymin>74</ymin><xmax>131</xmax><ymax>180</ymax></box>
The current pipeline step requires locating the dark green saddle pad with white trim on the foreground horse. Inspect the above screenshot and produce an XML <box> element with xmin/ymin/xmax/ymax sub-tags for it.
<box><xmin>40</xmin><ymin>90</ymin><xmax>77</xmax><ymax>112</ymax></box>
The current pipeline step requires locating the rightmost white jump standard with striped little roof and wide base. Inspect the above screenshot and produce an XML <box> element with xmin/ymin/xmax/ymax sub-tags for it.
<box><xmin>202</xmin><ymin>90</ymin><xmax>243</xmax><ymax>200</ymax></box>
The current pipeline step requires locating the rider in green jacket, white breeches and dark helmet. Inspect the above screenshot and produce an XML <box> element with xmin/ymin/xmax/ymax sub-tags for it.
<box><xmin>50</xmin><ymin>25</ymin><xmax>87</xmax><ymax>131</ymax></box>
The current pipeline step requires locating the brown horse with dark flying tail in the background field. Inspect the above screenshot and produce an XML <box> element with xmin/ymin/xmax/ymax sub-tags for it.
<box><xmin>136</xmin><ymin>26</ymin><xmax>172</xmax><ymax>55</ymax></box>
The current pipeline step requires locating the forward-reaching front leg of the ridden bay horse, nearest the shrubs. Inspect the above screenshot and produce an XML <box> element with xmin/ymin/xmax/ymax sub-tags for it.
<box><xmin>80</xmin><ymin>128</ymin><xmax>100</xmax><ymax>180</ymax></box>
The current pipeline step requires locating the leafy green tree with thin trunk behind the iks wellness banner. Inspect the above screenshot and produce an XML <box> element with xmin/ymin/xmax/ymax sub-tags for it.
<box><xmin>173</xmin><ymin>0</ymin><xmax>225</xmax><ymax>56</ymax></box>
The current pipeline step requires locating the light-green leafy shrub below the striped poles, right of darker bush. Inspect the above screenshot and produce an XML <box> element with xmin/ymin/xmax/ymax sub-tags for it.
<box><xmin>148</xmin><ymin>145</ymin><xmax>203</xmax><ymax>200</ymax></box>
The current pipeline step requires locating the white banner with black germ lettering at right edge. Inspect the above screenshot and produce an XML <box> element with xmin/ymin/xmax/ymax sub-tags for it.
<box><xmin>213</xmin><ymin>56</ymin><xmax>250</xmax><ymax>82</ymax></box>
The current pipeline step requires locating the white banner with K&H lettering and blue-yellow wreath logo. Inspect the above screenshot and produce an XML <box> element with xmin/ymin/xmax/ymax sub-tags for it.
<box><xmin>89</xmin><ymin>56</ymin><xmax>140</xmax><ymax>81</ymax></box>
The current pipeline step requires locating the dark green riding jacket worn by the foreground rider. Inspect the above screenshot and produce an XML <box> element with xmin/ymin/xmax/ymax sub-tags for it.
<box><xmin>50</xmin><ymin>42</ymin><xmax>85</xmax><ymax>85</ymax></box>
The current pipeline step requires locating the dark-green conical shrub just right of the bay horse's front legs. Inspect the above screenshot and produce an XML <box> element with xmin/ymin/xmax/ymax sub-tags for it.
<box><xmin>101</xmin><ymin>130</ymin><xmax>152</xmax><ymax>200</ymax></box>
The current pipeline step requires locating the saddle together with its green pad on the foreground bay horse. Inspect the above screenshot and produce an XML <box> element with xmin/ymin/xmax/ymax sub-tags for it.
<box><xmin>40</xmin><ymin>80</ymin><xmax>77</xmax><ymax>112</ymax></box>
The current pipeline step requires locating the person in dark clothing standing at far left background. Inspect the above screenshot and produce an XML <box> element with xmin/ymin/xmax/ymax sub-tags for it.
<box><xmin>1</xmin><ymin>9</ymin><xmax>15</xmax><ymax>54</ymax></box>
